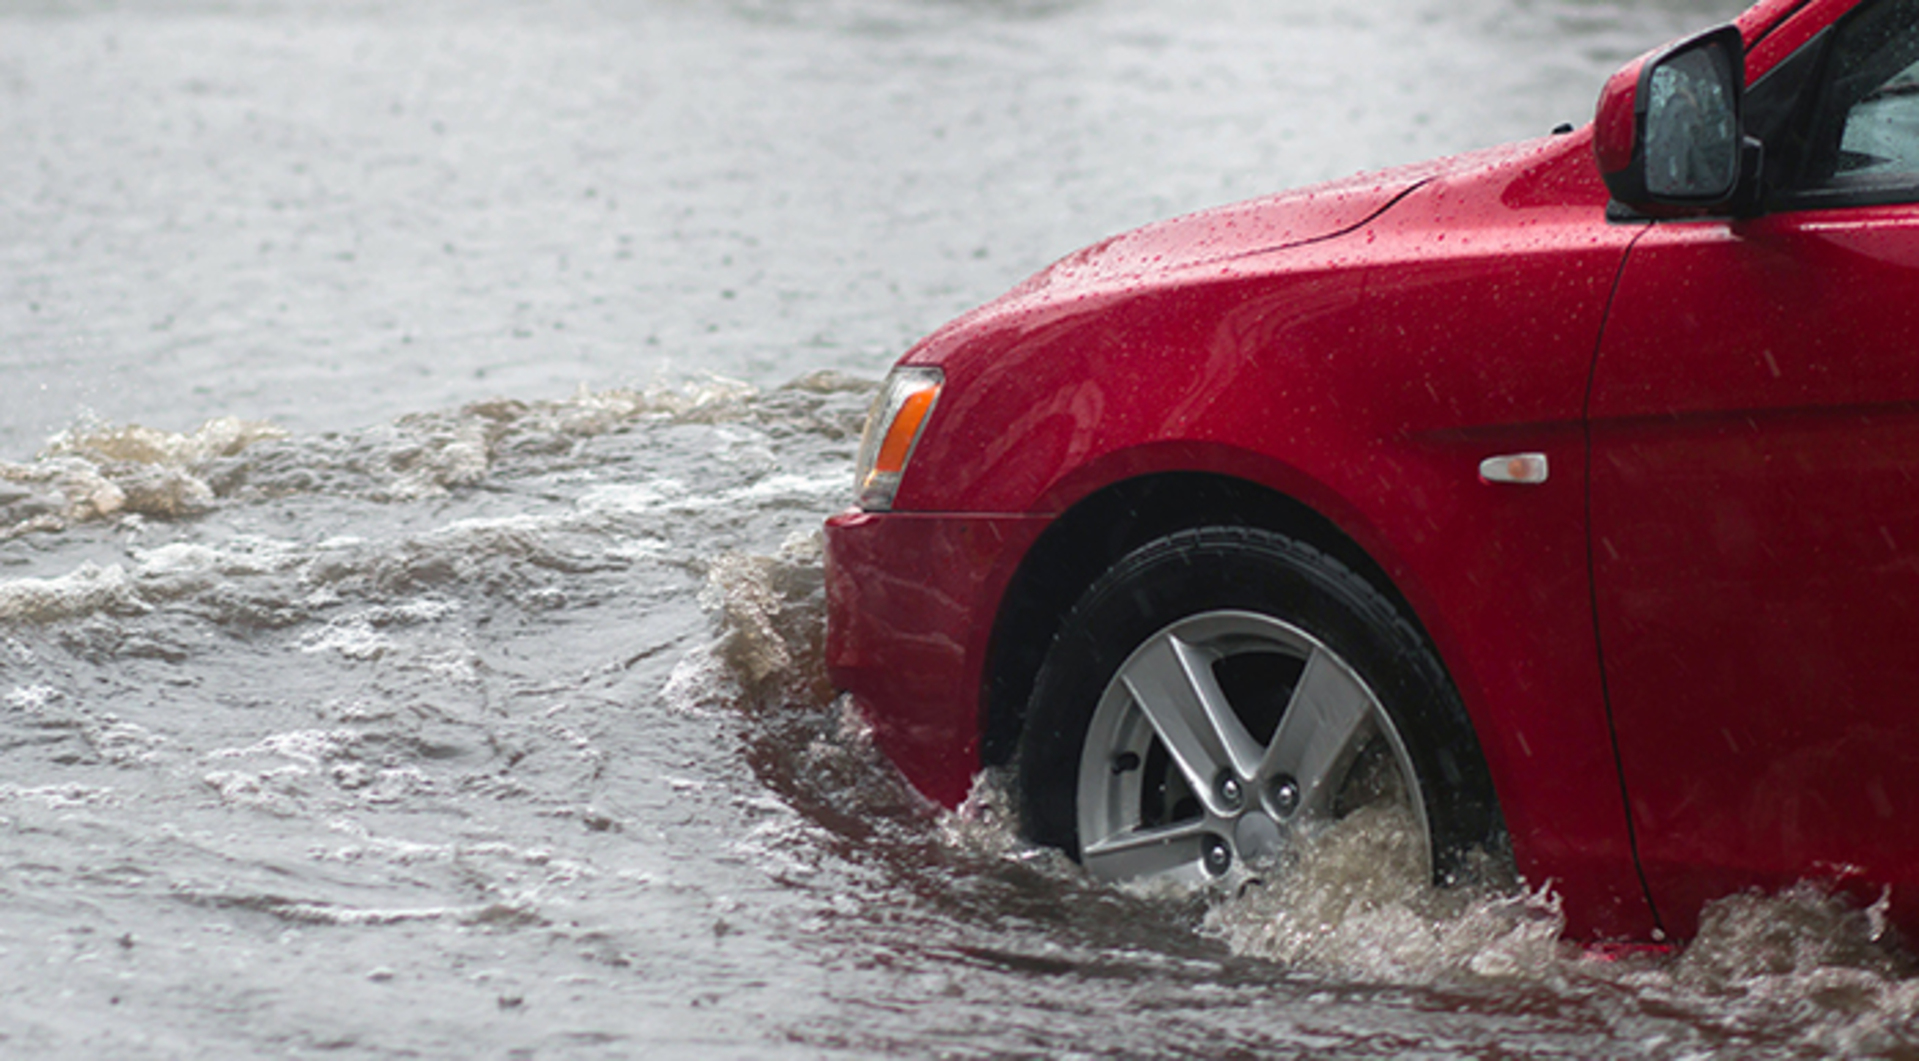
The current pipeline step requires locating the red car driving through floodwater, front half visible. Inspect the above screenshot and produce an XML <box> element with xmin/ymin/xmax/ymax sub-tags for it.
<box><xmin>827</xmin><ymin>0</ymin><xmax>1919</xmax><ymax>938</ymax></box>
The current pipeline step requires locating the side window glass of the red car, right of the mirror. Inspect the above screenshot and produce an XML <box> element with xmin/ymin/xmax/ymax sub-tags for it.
<box><xmin>1800</xmin><ymin>0</ymin><xmax>1919</xmax><ymax>201</ymax></box>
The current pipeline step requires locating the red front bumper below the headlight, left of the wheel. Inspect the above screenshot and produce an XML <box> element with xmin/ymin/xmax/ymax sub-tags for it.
<box><xmin>825</xmin><ymin>508</ymin><xmax>1050</xmax><ymax>808</ymax></box>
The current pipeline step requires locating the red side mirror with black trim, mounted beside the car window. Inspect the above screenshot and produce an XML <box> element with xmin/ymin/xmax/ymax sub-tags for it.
<box><xmin>1593</xmin><ymin>25</ymin><xmax>1758</xmax><ymax>217</ymax></box>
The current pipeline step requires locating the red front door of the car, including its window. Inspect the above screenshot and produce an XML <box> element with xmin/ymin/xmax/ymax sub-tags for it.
<box><xmin>1589</xmin><ymin>0</ymin><xmax>1919</xmax><ymax>932</ymax></box>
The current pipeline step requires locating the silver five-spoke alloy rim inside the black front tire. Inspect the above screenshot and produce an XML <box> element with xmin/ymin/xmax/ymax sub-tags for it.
<box><xmin>1077</xmin><ymin>610</ymin><xmax>1432</xmax><ymax>883</ymax></box>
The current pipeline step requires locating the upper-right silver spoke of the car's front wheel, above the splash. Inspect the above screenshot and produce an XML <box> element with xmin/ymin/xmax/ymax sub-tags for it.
<box><xmin>1259</xmin><ymin>648</ymin><xmax>1376</xmax><ymax>815</ymax></box>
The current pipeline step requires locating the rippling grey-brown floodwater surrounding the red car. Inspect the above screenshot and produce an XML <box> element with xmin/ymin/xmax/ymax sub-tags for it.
<box><xmin>0</xmin><ymin>0</ymin><xmax>1919</xmax><ymax>1059</ymax></box>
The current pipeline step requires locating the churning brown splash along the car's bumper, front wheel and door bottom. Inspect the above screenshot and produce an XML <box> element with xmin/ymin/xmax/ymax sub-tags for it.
<box><xmin>677</xmin><ymin>535</ymin><xmax>1919</xmax><ymax>1055</ymax></box>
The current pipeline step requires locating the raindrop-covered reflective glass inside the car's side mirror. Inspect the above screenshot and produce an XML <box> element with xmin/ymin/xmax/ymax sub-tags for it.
<box><xmin>1647</xmin><ymin>44</ymin><xmax>1739</xmax><ymax>200</ymax></box>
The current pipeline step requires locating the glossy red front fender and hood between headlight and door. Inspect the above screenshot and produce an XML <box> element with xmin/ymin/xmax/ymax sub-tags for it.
<box><xmin>900</xmin><ymin>134</ymin><xmax>1652</xmax><ymax>934</ymax></box>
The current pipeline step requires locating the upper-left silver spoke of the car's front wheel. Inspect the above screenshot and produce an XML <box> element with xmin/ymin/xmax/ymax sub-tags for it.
<box><xmin>1119</xmin><ymin>635</ymin><xmax>1261</xmax><ymax>801</ymax></box>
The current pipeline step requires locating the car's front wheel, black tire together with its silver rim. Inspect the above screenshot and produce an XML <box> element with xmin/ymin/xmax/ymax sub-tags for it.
<box><xmin>1017</xmin><ymin>528</ymin><xmax>1503</xmax><ymax>883</ymax></box>
